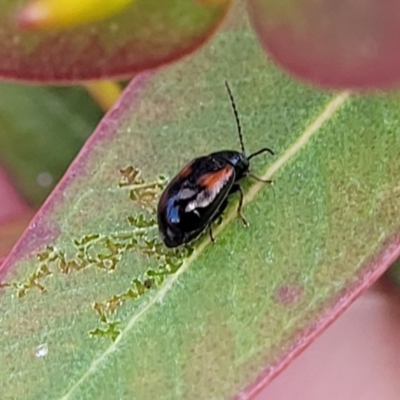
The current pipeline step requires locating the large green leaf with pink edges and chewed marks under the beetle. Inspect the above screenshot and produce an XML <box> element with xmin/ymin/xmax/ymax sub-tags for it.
<box><xmin>0</xmin><ymin>2</ymin><xmax>400</xmax><ymax>400</ymax></box>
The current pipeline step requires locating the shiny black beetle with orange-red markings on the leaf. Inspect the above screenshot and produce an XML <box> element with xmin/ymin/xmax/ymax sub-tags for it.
<box><xmin>157</xmin><ymin>81</ymin><xmax>274</xmax><ymax>248</ymax></box>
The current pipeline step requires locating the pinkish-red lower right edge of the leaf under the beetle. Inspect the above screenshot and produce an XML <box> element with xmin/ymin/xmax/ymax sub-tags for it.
<box><xmin>238</xmin><ymin>232</ymin><xmax>400</xmax><ymax>400</ymax></box>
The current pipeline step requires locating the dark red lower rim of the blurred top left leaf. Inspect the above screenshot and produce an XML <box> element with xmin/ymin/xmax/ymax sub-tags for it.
<box><xmin>0</xmin><ymin>1</ymin><xmax>233</xmax><ymax>85</ymax></box>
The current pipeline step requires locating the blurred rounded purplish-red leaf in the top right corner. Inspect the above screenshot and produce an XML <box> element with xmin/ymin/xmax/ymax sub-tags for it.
<box><xmin>248</xmin><ymin>0</ymin><xmax>400</xmax><ymax>89</ymax></box>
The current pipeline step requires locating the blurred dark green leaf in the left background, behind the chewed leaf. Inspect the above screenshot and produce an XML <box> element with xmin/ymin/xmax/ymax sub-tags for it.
<box><xmin>0</xmin><ymin>83</ymin><xmax>102</xmax><ymax>206</ymax></box>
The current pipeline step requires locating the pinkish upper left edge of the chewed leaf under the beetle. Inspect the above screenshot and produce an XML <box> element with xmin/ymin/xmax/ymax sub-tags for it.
<box><xmin>0</xmin><ymin>72</ymin><xmax>153</xmax><ymax>278</ymax></box>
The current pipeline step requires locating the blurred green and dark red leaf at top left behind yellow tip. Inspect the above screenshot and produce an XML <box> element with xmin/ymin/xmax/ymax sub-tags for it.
<box><xmin>0</xmin><ymin>0</ymin><xmax>231</xmax><ymax>81</ymax></box>
